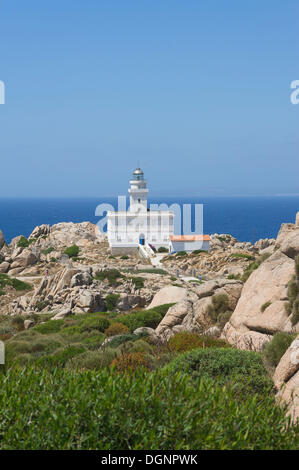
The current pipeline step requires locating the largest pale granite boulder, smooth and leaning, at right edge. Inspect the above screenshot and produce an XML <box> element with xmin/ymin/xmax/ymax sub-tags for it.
<box><xmin>222</xmin><ymin>212</ymin><xmax>299</xmax><ymax>350</ymax></box>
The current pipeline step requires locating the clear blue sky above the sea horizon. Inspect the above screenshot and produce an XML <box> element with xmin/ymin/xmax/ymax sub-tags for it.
<box><xmin>0</xmin><ymin>0</ymin><xmax>299</xmax><ymax>197</ymax></box>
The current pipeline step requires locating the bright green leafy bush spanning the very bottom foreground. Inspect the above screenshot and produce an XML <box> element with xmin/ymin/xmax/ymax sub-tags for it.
<box><xmin>0</xmin><ymin>367</ymin><xmax>298</xmax><ymax>450</ymax></box>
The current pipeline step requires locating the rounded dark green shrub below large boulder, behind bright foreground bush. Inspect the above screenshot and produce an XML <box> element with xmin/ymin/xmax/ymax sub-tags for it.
<box><xmin>166</xmin><ymin>348</ymin><xmax>273</xmax><ymax>398</ymax></box>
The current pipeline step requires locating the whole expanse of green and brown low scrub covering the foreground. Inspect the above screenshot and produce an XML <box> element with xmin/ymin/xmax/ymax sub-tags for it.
<box><xmin>0</xmin><ymin>299</ymin><xmax>299</xmax><ymax>450</ymax></box>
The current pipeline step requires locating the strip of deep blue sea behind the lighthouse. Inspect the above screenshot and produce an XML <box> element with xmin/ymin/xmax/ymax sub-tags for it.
<box><xmin>0</xmin><ymin>196</ymin><xmax>299</xmax><ymax>242</ymax></box>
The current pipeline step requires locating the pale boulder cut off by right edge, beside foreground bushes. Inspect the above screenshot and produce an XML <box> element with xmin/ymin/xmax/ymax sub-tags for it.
<box><xmin>273</xmin><ymin>336</ymin><xmax>299</xmax><ymax>421</ymax></box>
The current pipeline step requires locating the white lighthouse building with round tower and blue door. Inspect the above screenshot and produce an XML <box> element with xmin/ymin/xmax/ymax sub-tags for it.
<box><xmin>107</xmin><ymin>168</ymin><xmax>174</xmax><ymax>254</ymax></box>
